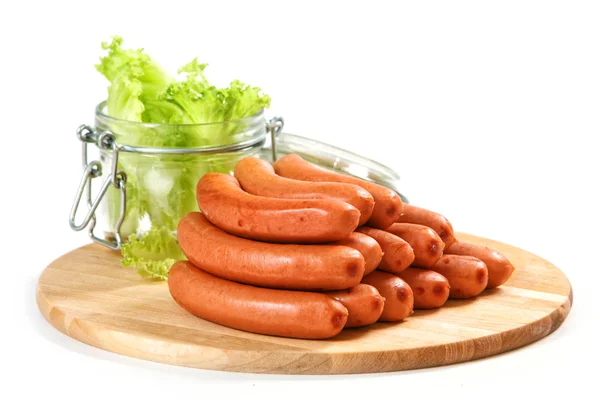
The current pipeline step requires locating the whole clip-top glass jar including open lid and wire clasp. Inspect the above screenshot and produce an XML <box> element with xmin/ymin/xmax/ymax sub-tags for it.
<box><xmin>70</xmin><ymin>102</ymin><xmax>408</xmax><ymax>255</ymax></box>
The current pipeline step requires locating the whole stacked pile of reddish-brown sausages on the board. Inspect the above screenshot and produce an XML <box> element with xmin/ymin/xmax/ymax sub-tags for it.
<box><xmin>168</xmin><ymin>154</ymin><xmax>514</xmax><ymax>339</ymax></box>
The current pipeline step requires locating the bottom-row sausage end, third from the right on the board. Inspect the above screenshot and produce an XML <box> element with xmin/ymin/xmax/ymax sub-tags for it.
<box><xmin>398</xmin><ymin>268</ymin><xmax>450</xmax><ymax>309</ymax></box>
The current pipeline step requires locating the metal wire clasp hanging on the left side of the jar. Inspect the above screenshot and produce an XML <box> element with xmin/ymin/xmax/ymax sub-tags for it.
<box><xmin>69</xmin><ymin>125</ymin><xmax>127</xmax><ymax>250</ymax></box>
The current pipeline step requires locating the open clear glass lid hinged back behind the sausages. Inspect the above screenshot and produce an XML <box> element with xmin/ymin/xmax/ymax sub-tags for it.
<box><xmin>261</xmin><ymin>132</ymin><xmax>409</xmax><ymax>203</ymax></box>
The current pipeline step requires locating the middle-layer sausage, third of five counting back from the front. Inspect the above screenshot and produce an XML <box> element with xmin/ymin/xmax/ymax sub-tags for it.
<box><xmin>357</xmin><ymin>226</ymin><xmax>415</xmax><ymax>273</ymax></box>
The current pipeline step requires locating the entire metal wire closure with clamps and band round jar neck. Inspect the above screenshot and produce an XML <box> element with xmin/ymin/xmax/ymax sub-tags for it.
<box><xmin>69</xmin><ymin>117</ymin><xmax>283</xmax><ymax>250</ymax></box>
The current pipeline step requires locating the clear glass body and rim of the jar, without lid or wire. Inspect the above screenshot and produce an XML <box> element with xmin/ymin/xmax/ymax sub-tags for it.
<box><xmin>95</xmin><ymin>103</ymin><xmax>266</xmax><ymax>240</ymax></box>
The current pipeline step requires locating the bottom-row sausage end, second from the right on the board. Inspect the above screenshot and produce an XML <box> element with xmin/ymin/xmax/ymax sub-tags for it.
<box><xmin>431</xmin><ymin>254</ymin><xmax>488</xmax><ymax>299</ymax></box>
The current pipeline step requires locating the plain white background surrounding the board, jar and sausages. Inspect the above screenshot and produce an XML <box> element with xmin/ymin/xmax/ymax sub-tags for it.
<box><xmin>0</xmin><ymin>0</ymin><xmax>600</xmax><ymax>399</ymax></box>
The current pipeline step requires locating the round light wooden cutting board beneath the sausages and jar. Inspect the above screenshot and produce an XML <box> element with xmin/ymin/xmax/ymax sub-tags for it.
<box><xmin>37</xmin><ymin>234</ymin><xmax>573</xmax><ymax>374</ymax></box>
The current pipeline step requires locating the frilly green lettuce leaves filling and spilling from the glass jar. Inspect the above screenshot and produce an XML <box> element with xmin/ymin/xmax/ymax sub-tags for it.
<box><xmin>96</xmin><ymin>36</ymin><xmax>271</xmax><ymax>279</ymax></box>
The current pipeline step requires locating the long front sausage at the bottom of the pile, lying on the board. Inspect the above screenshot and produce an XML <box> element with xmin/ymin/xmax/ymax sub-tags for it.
<box><xmin>168</xmin><ymin>261</ymin><xmax>348</xmax><ymax>339</ymax></box>
